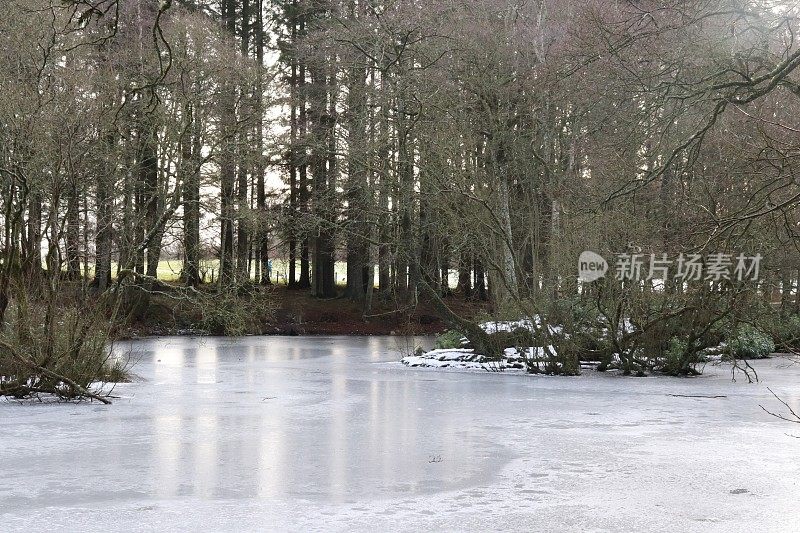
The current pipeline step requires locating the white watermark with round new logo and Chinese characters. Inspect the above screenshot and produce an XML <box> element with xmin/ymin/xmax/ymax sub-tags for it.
<box><xmin>578</xmin><ymin>250</ymin><xmax>763</xmax><ymax>282</ymax></box>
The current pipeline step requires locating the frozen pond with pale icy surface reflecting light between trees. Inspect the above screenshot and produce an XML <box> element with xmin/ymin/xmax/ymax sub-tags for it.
<box><xmin>0</xmin><ymin>337</ymin><xmax>800</xmax><ymax>532</ymax></box>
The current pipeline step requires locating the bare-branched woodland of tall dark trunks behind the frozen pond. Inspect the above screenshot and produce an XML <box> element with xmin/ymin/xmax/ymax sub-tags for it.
<box><xmin>0</xmin><ymin>0</ymin><xmax>800</xmax><ymax>399</ymax></box>
